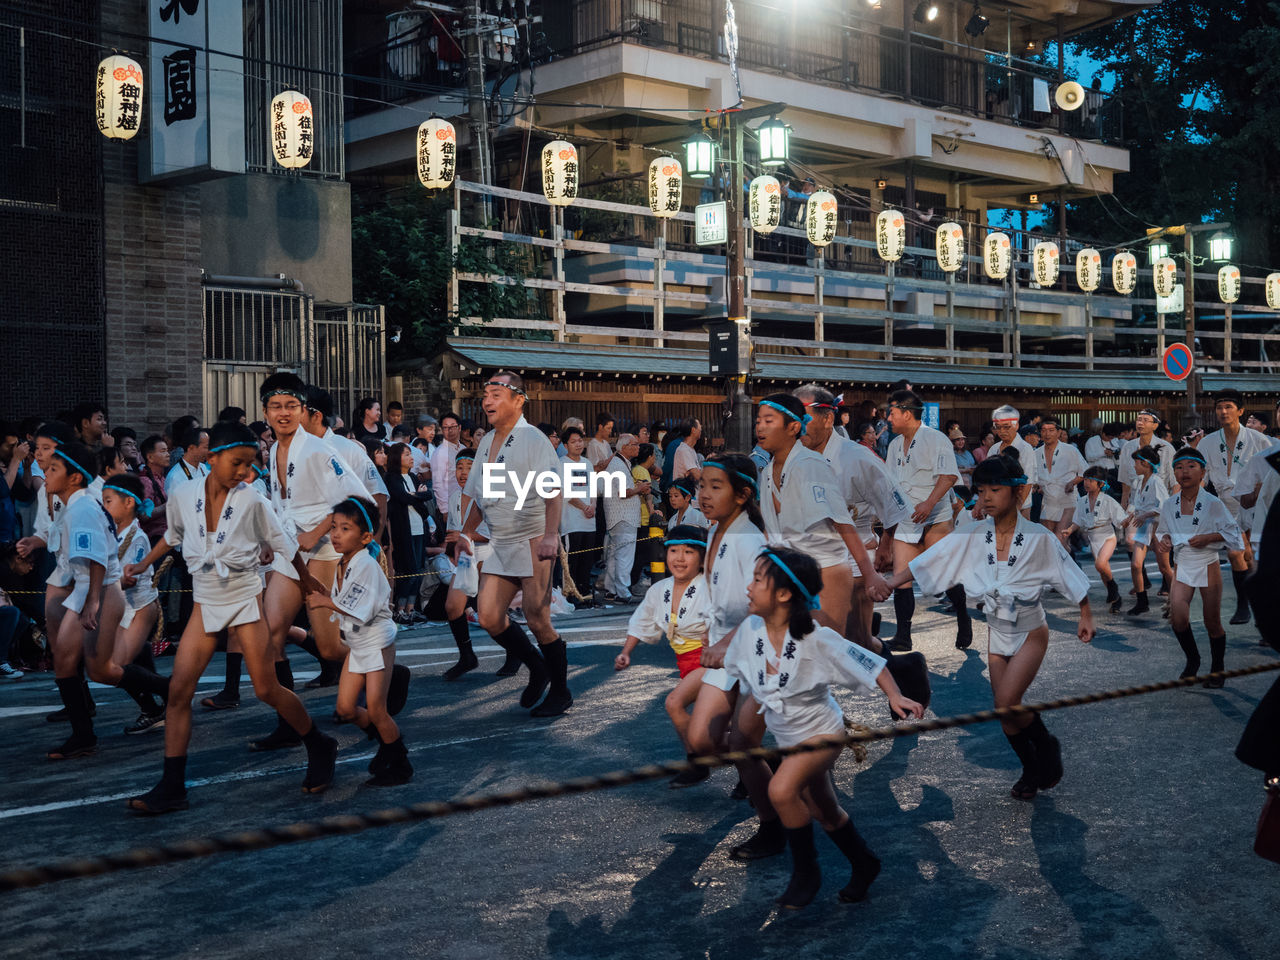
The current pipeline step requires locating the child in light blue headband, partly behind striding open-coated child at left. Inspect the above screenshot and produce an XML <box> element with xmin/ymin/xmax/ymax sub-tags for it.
<box><xmin>102</xmin><ymin>475</ymin><xmax>165</xmax><ymax>733</ymax></box>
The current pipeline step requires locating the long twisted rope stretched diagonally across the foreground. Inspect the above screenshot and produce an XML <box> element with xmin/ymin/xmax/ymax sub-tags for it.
<box><xmin>0</xmin><ymin>662</ymin><xmax>1280</xmax><ymax>892</ymax></box>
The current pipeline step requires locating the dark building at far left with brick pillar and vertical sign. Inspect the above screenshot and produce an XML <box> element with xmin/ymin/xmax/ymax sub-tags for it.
<box><xmin>0</xmin><ymin>0</ymin><xmax>383</xmax><ymax>430</ymax></box>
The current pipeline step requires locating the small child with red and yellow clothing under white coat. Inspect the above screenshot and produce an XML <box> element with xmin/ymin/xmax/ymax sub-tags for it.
<box><xmin>613</xmin><ymin>525</ymin><xmax>712</xmax><ymax>788</ymax></box>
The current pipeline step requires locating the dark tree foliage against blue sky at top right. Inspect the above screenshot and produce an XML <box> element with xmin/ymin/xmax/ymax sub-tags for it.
<box><xmin>1069</xmin><ymin>0</ymin><xmax>1280</xmax><ymax>265</ymax></box>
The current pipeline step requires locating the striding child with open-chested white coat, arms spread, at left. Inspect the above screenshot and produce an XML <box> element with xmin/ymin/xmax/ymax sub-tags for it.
<box><xmin>125</xmin><ymin>422</ymin><xmax>338</xmax><ymax>814</ymax></box>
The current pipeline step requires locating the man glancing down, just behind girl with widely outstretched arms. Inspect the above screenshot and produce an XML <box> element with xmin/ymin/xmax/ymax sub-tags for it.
<box><xmin>884</xmin><ymin>390</ymin><xmax>973</xmax><ymax>652</ymax></box>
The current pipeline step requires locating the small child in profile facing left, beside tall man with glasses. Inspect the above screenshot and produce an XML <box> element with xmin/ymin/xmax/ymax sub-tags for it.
<box><xmin>307</xmin><ymin>497</ymin><xmax>413</xmax><ymax>787</ymax></box>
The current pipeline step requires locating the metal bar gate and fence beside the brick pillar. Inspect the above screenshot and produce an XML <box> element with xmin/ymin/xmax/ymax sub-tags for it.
<box><xmin>204</xmin><ymin>287</ymin><xmax>385</xmax><ymax>424</ymax></box>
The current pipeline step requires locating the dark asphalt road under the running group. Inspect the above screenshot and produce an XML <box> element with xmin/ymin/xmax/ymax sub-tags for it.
<box><xmin>0</xmin><ymin>578</ymin><xmax>1280</xmax><ymax>960</ymax></box>
